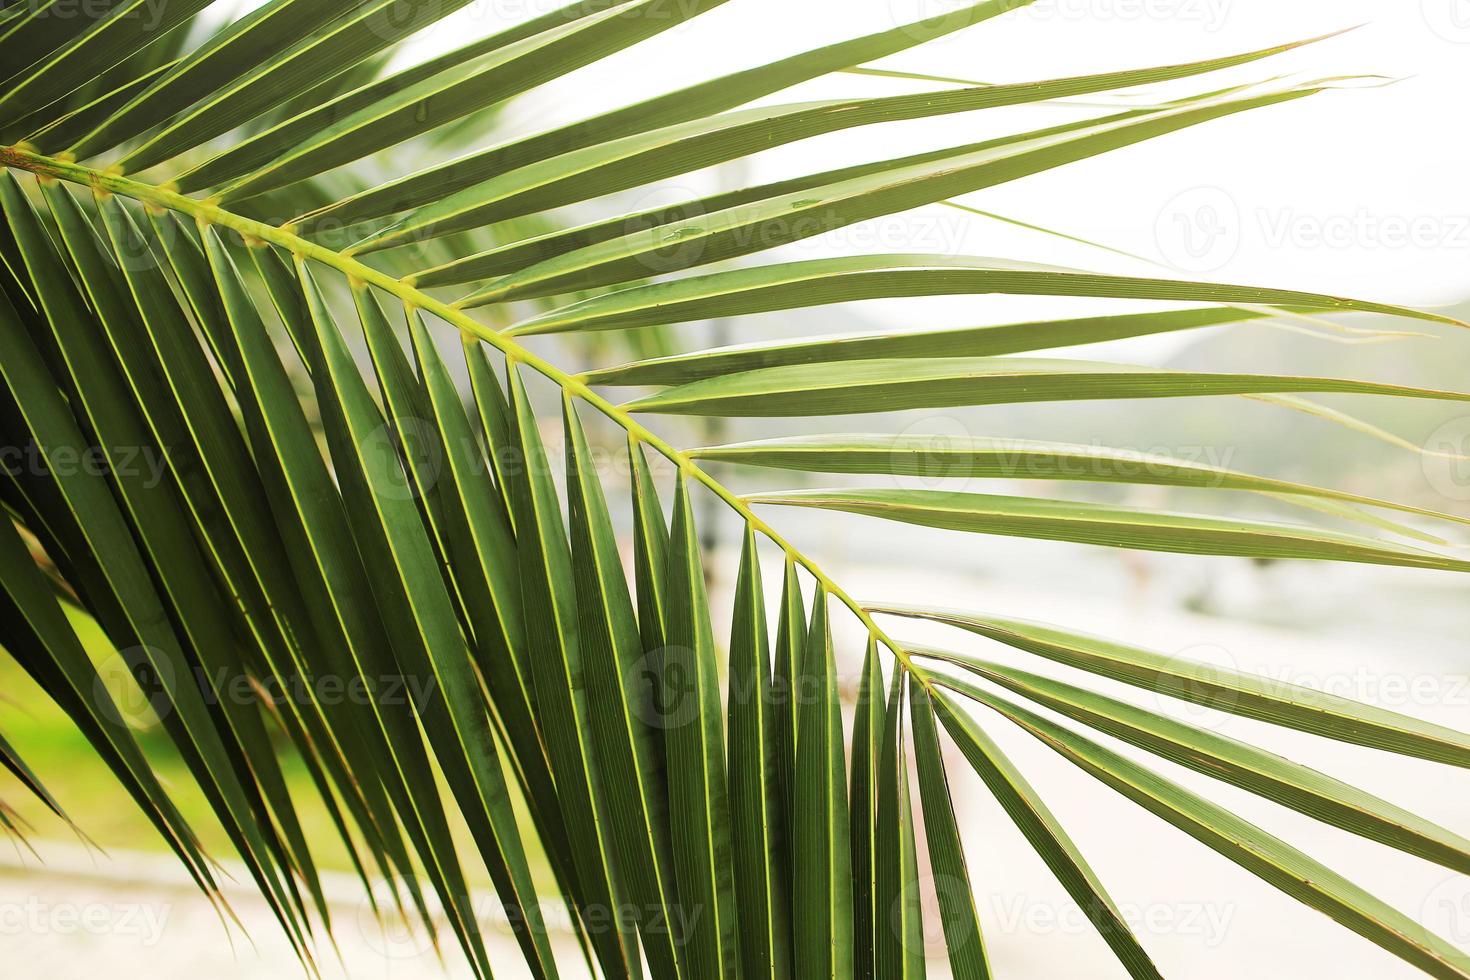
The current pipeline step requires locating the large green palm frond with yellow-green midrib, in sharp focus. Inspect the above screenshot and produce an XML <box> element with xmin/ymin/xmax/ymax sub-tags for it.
<box><xmin>0</xmin><ymin>0</ymin><xmax>1470</xmax><ymax>980</ymax></box>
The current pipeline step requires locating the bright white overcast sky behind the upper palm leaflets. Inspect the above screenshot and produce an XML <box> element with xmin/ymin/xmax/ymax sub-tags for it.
<box><xmin>396</xmin><ymin>0</ymin><xmax>1470</xmax><ymax>319</ymax></box>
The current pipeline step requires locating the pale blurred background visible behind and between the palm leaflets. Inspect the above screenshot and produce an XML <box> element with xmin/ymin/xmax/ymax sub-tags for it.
<box><xmin>0</xmin><ymin>0</ymin><xmax>1470</xmax><ymax>980</ymax></box>
